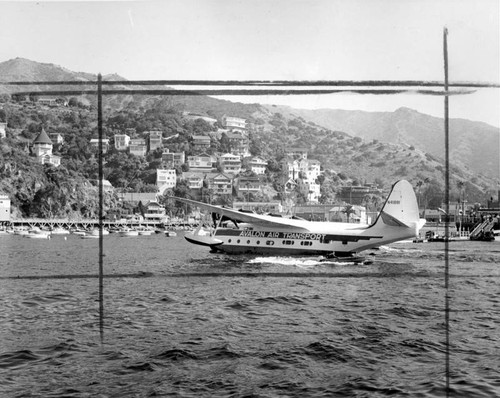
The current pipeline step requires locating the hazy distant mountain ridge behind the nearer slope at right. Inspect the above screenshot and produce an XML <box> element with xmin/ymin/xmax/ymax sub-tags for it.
<box><xmin>267</xmin><ymin>106</ymin><xmax>500</xmax><ymax>179</ymax></box>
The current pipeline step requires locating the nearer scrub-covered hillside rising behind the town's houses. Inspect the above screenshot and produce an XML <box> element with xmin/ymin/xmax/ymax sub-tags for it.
<box><xmin>0</xmin><ymin>59</ymin><xmax>498</xmax><ymax>216</ymax></box>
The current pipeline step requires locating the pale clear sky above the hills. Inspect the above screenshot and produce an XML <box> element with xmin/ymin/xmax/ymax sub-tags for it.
<box><xmin>0</xmin><ymin>0</ymin><xmax>500</xmax><ymax>127</ymax></box>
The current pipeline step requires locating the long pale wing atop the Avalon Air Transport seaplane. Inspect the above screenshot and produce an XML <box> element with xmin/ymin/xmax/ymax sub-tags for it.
<box><xmin>170</xmin><ymin>196</ymin><xmax>309</xmax><ymax>232</ymax></box>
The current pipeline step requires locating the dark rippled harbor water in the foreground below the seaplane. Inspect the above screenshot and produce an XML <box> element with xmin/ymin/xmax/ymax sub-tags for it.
<box><xmin>0</xmin><ymin>234</ymin><xmax>500</xmax><ymax>397</ymax></box>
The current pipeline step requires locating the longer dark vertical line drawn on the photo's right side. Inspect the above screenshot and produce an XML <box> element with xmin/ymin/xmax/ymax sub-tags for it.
<box><xmin>443</xmin><ymin>27</ymin><xmax>450</xmax><ymax>397</ymax></box>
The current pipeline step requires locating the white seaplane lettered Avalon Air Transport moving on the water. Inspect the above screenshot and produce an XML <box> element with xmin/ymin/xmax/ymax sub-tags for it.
<box><xmin>172</xmin><ymin>180</ymin><xmax>425</xmax><ymax>260</ymax></box>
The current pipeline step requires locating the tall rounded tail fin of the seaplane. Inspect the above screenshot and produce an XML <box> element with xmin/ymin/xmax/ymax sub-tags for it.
<box><xmin>374</xmin><ymin>180</ymin><xmax>425</xmax><ymax>236</ymax></box>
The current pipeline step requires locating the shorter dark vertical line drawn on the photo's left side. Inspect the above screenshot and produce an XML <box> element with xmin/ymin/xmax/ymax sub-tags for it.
<box><xmin>97</xmin><ymin>73</ymin><xmax>104</xmax><ymax>343</ymax></box>
